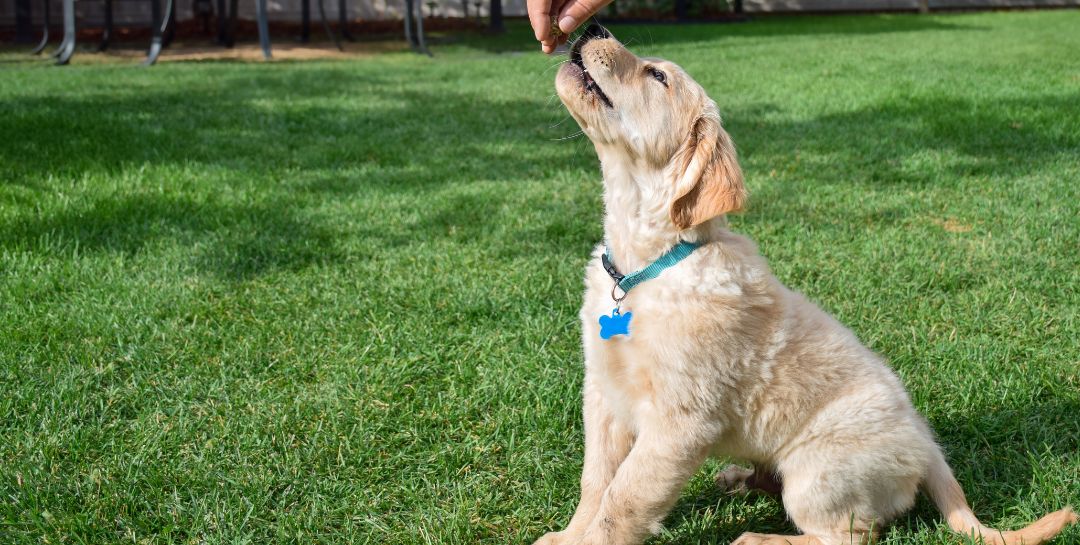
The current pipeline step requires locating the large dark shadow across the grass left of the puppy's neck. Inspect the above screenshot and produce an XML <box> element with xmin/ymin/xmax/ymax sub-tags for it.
<box><xmin>0</xmin><ymin>69</ymin><xmax>593</xmax><ymax>276</ymax></box>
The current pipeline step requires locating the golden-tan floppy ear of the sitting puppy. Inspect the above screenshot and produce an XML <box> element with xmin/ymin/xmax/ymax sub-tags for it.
<box><xmin>667</xmin><ymin>105</ymin><xmax>746</xmax><ymax>229</ymax></box>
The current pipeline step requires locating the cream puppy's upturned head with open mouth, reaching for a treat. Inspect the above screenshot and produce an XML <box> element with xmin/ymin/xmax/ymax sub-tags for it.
<box><xmin>555</xmin><ymin>24</ymin><xmax>746</xmax><ymax>229</ymax></box>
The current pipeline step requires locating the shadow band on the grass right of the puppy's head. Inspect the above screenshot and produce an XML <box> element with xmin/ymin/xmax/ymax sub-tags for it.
<box><xmin>725</xmin><ymin>96</ymin><xmax>1080</xmax><ymax>189</ymax></box>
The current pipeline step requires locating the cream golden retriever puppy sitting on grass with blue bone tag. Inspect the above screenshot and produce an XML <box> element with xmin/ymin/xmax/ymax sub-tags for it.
<box><xmin>537</xmin><ymin>25</ymin><xmax>1076</xmax><ymax>545</ymax></box>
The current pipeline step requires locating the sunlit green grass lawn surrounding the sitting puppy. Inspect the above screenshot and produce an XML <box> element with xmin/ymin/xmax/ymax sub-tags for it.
<box><xmin>0</xmin><ymin>11</ymin><xmax>1080</xmax><ymax>544</ymax></box>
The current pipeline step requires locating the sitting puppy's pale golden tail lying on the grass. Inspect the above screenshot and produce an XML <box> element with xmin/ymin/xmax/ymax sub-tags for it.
<box><xmin>922</xmin><ymin>449</ymin><xmax>1077</xmax><ymax>545</ymax></box>
